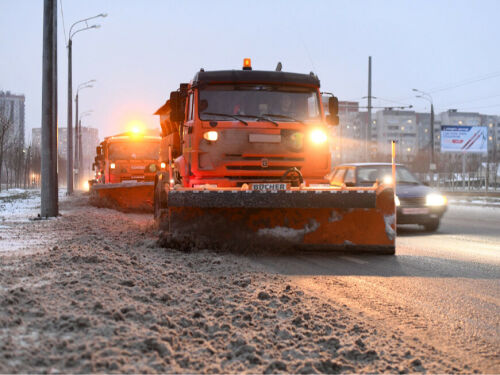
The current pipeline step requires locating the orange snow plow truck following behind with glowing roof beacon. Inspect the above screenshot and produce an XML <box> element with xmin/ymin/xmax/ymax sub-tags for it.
<box><xmin>90</xmin><ymin>132</ymin><xmax>162</xmax><ymax>212</ymax></box>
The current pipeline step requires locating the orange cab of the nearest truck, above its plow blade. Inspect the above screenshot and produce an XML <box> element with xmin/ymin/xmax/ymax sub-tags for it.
<box><xmin>156</xmin><ymin>64</ymin><xmax>338</xmax><ymax>188</ymax></box>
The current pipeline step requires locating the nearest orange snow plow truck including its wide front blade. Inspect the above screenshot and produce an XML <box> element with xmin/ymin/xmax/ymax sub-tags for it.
<box><xmin>154</xmin><ymin>59</ymin><xmax>396</xmax><ymax>254</ymax></box>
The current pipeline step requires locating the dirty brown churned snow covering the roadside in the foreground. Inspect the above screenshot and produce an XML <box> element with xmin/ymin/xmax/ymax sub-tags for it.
<box><xmin>0</xmin><ymin>198</ymin><xmax>472</xmax><ymax>373</ymax></box>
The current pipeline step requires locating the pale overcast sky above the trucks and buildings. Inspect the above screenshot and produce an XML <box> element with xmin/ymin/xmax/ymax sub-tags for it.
<box><xmin>0</xmin><ymin>0</ymin><xmax>500</xmax><ymax>142</ymax></box>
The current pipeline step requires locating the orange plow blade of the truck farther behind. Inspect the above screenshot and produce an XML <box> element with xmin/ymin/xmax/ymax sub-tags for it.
<box><xmin>90</xmin><ymin>182</ymin><xmax>154</xmax><ymax>212</ymax></box>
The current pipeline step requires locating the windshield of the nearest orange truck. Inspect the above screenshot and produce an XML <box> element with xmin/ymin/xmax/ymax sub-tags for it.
<box><xmin>198</xmin><ymin>84</ymin><xmax>321</xmax><ymax>122</ymax></box>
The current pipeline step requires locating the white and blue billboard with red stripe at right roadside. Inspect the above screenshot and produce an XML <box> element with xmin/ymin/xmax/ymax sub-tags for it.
<box><xmin>441</xmin><ymin>125</ymin><xmax>488</xmax><ymax>153</ymax></box>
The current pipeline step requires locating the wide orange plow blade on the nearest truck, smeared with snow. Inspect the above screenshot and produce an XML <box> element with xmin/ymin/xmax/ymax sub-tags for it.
<box><xmin>160</xmin><ymin>186</ymin><xmax>396</xmax><ymax>254</ymax></box>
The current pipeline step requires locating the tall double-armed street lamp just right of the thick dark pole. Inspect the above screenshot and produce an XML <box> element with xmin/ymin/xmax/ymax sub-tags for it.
<box><xmin>66</xmin><ymin>13</ymin><xmax>107</xmax><ymax>195</ymax></box>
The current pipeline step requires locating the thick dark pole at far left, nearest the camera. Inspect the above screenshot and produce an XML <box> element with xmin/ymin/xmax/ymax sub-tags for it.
<box><xmin>40</xmin><ymin>0</ymin><xmax>59</xmax><ymax>217</ymax></box>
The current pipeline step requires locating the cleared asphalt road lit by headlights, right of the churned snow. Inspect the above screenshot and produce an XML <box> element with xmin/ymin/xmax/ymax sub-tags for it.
<box><xmin>256</xmin><ymin>205</ymin><xmax>500</xmax><ymax>373</ymax></box>
